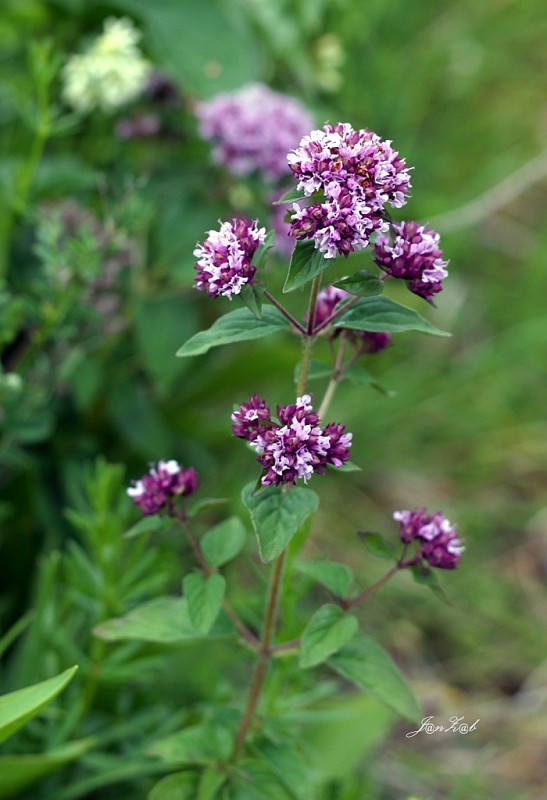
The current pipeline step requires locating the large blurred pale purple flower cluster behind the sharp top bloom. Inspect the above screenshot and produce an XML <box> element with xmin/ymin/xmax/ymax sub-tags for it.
<box><xmin>195</xmin><ymin>83</ymin><xmax>313</xmax><ymax>183</ymax></box>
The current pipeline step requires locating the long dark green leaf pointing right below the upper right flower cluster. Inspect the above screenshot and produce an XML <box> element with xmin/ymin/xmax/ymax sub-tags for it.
<box><xmin>336</xmin><ymin>297</ymin><xmax>450</xmax><ymax>336</ymax></box>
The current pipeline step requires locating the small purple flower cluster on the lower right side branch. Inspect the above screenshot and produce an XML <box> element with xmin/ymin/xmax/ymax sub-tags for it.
<box><xmin>393</xmin><ymin>508</ymin><xmax>465</xmax><ymax>569</ymax></box>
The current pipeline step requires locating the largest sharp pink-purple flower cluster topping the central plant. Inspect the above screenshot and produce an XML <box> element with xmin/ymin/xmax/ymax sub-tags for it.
<box><xmin>287</xmin><ymin>122</ymin><xmax>410</xmax><ymax>258</ymax></box>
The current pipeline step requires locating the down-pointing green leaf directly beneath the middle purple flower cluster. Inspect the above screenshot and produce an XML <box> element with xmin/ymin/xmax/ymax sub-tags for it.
<box><xmin>242</xmin><ymin>483</ymin><xmax>319</xmax><ymax>563</ymax></box>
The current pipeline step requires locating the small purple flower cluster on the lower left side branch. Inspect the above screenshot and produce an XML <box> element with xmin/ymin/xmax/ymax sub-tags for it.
<box><xmin>127</xmin><ymin>459</ymin><xmax>199</xmax><ymax>517</ymax></box>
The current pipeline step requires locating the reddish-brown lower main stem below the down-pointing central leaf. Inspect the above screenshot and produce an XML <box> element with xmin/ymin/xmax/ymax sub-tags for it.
<box><xmin>230</xmin><ymin>551</ymin><xmax>285</xmax><ymax>762</ymax></box>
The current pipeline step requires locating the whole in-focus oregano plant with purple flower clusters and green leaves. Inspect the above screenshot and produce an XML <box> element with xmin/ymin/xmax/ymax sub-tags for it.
<box><xmin>95</xmin><ymin>123</ymin><xmax>463</xmax><ymax>800</ymax></box>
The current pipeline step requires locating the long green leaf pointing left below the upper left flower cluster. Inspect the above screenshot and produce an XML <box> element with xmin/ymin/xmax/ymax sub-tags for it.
<box><xmin>177</xmin><ymin>305</ymin><xmax>287</xmax><ymax>358</ymax></box>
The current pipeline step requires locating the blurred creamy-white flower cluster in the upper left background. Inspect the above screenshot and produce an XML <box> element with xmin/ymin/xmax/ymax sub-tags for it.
<box><xmin>62</xmin><ymin>17</ymin><xmax>152</xmax><ymax>113</ymax></box>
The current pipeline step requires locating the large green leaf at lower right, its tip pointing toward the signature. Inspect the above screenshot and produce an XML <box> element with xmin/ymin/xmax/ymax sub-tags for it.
<box><xmin>327</xmin><ymin>634</ymin><xmax>422</xmax><ymax>722</ymax></box>
